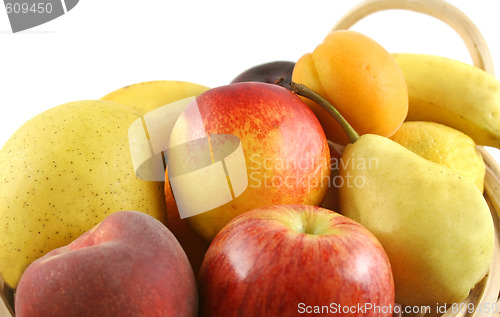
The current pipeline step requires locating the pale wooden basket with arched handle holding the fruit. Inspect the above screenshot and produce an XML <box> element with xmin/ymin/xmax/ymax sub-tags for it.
<box><xmin>331</xmin><ymin>0</ymin><xmax>500</xmax><ymax>317</ymax></box>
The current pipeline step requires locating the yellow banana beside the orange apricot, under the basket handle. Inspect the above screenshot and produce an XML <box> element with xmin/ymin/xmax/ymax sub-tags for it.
<box><xmin>393</xmin><ymin>53</ymin><xmax>500</xmax><ymax>148</ymax></box>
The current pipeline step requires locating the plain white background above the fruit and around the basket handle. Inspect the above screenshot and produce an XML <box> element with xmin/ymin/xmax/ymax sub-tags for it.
<box><xmin>0</xmin><ymin>0</ymin><xmax>500</xmax><ymax>158</ymax></box>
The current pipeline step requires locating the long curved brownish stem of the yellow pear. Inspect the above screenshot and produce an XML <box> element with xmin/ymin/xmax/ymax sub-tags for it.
<box><xmin>290</xmin><ymin>81</ymin><xmax>359</xmax><ymax>143</ymax></box>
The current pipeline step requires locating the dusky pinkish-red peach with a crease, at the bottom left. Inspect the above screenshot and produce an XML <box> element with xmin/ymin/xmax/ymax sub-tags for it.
<box><xmin>15</xmin><ymin>211</ymin><xmax>198</xmax><ymax>317</ymax></box>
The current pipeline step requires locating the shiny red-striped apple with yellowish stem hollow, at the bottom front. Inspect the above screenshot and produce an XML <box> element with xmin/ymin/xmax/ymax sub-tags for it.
<box><xmin>199</xmin><ymin>205</ymin><xmax>394</xmax><ymax>317</ymax></box>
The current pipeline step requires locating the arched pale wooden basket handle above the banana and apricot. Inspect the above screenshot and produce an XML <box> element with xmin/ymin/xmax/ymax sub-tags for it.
<box><xmin>331</xmin><ymin>0</ymin><xmax>494</xmax><ymax>75</ymax></box>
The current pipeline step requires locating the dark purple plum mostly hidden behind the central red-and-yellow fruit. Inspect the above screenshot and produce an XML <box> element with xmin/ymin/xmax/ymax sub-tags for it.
<box><xmin>231</xmin><ymin>61</ymin><xmax>295</xmax><ymax>88</ymax></box>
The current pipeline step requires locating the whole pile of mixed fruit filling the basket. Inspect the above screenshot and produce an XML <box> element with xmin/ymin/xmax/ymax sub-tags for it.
<box><xmin>0</xmin><ymin>12</ymin><xmax>500</xmax><ymax>317</ymax></box>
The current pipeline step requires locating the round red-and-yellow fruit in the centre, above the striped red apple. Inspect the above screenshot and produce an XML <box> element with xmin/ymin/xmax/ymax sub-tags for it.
<box><xmin>167</xmin><ymin>82</ymin><xmax>330</xmax><ymax>241</ymax></box>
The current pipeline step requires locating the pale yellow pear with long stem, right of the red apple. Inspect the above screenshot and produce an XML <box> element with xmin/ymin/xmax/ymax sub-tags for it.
<box><xmin>339</xmin><ymin>134</ymin><xmax>494</xmax><ymax>305</ymax></box>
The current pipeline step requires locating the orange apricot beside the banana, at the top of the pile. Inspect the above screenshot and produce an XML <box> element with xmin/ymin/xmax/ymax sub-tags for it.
<box><xmin>292</xmin><ymin>30</ymin><xmax>408</xmax><ymax>145</ymax></box>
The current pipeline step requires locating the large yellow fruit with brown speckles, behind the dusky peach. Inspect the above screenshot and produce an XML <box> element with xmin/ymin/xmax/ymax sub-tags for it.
<box><xmin>0</xmin><ymin>100</ymin><xmax>166</xmax><ymax>288</ymax></box>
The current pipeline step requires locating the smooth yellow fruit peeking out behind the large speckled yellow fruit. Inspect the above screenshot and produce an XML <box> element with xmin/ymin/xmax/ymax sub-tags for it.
<box><xmin>101</xmin><ymin>80</ymin><xmax>208</xmax><ymax>114</ymax></box>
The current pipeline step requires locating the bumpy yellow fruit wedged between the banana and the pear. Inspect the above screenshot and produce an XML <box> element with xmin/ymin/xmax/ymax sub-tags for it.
<box><xmin>391</xmin><ymin>121</ymin><xmax>486</xmax><ymax>192</ymax></box>
